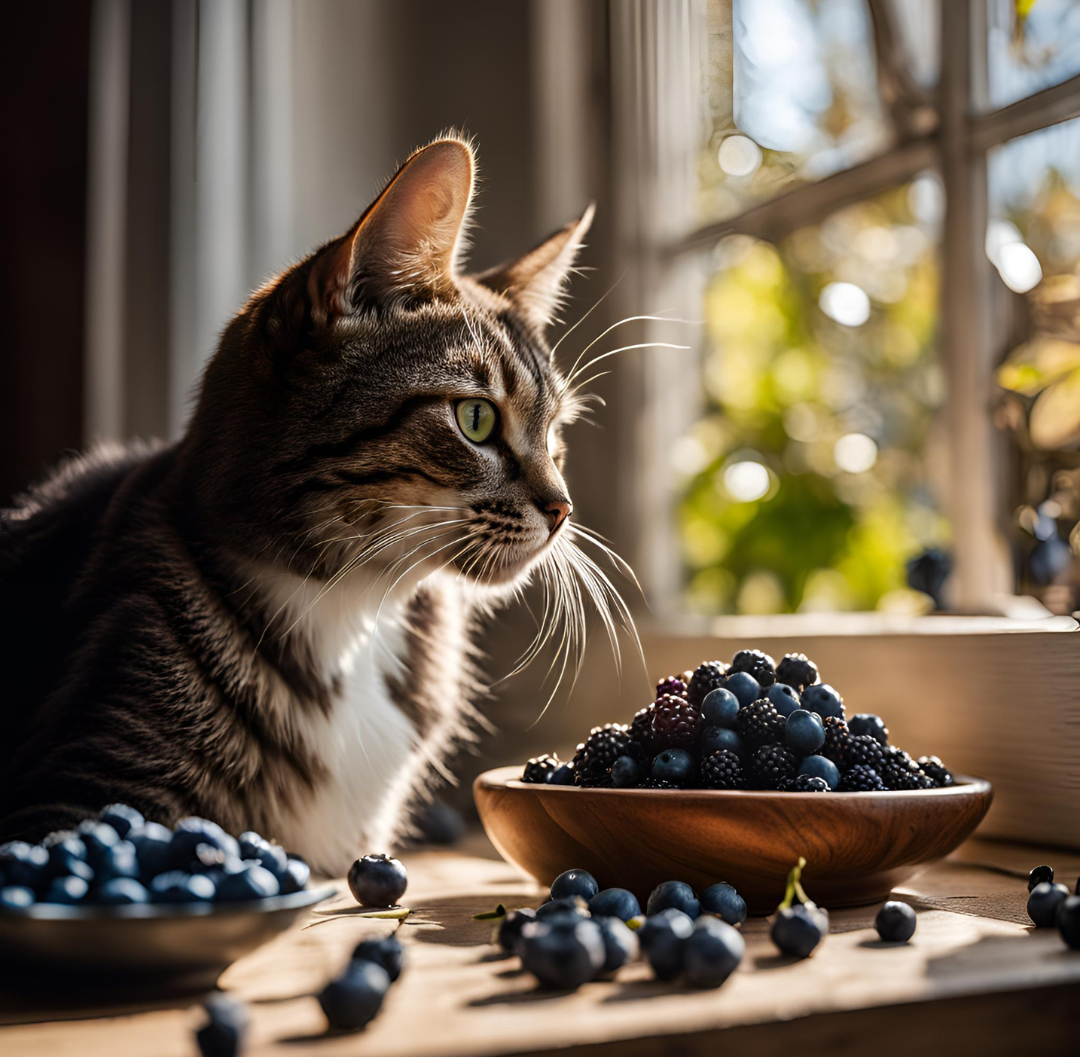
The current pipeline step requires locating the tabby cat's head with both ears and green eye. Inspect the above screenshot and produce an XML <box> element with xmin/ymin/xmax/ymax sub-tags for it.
<box><xmin>189</xmin><ymin>136</ymin><xmax>592</xmax><ymax>585</ymax></box>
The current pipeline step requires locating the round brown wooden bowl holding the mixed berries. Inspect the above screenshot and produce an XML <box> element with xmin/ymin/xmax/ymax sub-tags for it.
<box><xmin>473</xmin><ymin>767</ymin><xmax>994</xmax><ymax>913</ymax></box>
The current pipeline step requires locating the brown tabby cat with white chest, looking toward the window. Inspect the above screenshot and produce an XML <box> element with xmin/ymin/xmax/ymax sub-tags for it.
<box><xmin>0</xmin><ymin>136</ymin><xmax>609</xmax><ymax>872</ymax></box>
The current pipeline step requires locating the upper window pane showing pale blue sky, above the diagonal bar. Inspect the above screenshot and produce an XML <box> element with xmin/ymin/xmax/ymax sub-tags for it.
<box><xmin>699</xmin><ymin>0</ymin><xmax>890</xmax><ymax>221</ymax></box>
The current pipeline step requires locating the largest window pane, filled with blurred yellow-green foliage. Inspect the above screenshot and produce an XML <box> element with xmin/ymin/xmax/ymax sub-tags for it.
<box><xmin>672</xmin><ymin>174</ymin><xmax>947</xmax><ymax>613</ymax></box>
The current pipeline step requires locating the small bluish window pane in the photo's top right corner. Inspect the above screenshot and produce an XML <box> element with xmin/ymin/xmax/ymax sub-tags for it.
<box><xmin>984</xmin><ymin>0</ymin><xmax>1080</xmax><ymax>109</ymax></box>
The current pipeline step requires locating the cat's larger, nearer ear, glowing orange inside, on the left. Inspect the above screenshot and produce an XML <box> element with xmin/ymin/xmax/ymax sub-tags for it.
<box><xmin>259</xmin><ymin>137</ymin><xmax>476</xmax><ymax>337</ymax></box>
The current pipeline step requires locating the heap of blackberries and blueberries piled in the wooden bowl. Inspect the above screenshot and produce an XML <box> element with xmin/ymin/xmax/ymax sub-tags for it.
<box><xmin>522</xmin><ymin>650</ymin><xmax>953</xmax><ymax>792</ymax></box>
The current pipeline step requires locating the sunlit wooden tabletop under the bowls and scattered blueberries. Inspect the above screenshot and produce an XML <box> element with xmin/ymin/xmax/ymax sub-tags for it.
<box><xmin>0</xmin><ymin>837</ymin><xmax>1080</xmax><ymax>1057</ymax></box>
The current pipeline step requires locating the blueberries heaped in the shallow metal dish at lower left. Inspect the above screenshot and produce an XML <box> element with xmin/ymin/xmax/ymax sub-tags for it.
<box><xmin>0</xmin><ymin>803</ymin><xmax>311</xmax><ymax>911</ymax></box>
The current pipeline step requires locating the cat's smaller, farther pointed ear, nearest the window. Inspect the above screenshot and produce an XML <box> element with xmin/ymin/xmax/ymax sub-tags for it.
<box><xmin>476</xmin><ymin>204</ymin><xmax>596</xmax><ymax>331</ymax></box>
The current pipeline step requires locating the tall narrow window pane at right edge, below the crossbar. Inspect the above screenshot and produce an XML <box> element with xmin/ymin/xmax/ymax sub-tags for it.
<box><xmin>986</xmin><ymin>120</ymin><xmax>1080</xmax><ymax>613</ymax></box>
